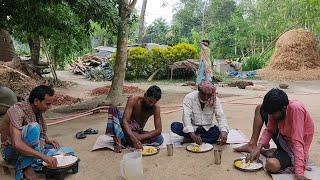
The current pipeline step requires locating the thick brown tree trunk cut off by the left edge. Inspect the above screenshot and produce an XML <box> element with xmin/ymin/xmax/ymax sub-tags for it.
<box><xmin>0</xmin><ymin>29</ymin><xmax>16</xmax><ymax>62</ymax></box>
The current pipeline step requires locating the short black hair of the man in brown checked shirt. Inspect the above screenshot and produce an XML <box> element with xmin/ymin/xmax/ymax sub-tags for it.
<box><xmin>29</xmin><ymin>85</ymin><xmax>54</xmax><ymax>104</ymax></box>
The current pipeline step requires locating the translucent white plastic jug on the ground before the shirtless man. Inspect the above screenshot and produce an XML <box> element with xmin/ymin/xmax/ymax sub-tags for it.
<box><xmin>120</xmin><ymin>152</ymin><xmax>144</xmax><ymax>180</ymax></box>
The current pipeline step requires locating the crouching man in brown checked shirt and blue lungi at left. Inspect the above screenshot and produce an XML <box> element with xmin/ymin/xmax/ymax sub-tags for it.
<box><xmin>0</xmin><ymin>85</ymin><xmax>72</xmax><ymax>180</ymax></box>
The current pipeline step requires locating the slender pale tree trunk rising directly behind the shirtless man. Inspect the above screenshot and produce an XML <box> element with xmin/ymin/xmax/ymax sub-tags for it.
<box><xmin>106</xmin><ymin>0</ymin><xmax>137</xmax><ymax>105</ymax></box>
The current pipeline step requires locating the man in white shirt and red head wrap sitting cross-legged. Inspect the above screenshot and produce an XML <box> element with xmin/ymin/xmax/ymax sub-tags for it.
<box><xmin>171</xmin><ymin>81</ymin><xmax>229</xmax><ymax>145</ymax></box>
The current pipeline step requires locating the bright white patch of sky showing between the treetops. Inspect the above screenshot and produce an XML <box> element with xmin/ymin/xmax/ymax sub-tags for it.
<box><xmin>136</xmin><ymin>0</ymin><xmax>179</xmax><ymax>25</ymax></box>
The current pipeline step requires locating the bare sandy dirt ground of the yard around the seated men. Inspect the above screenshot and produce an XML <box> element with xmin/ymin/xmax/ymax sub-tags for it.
<box><xmin>0</xmin><ymin>72</ymin><xmax>320</xmax><ymax>180</ymax></box>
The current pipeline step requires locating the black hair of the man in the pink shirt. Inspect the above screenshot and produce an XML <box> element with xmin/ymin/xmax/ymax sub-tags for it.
<box><xmin>262</xmin><ymin>88</ymin><xmax>289</xmax><ymax>114</ymax></box>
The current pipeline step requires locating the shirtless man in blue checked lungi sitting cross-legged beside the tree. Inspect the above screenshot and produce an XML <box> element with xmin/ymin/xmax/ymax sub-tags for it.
<box><xmin>106</xmin><ymin>86</ymin><xmax>163</xmax><ymax>152</ymax></box>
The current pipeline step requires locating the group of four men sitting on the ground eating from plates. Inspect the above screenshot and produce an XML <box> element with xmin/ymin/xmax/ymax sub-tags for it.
<box><xmin>0</xmin><ymin>81</ymin><xmax>314</xmax><ymax>179</ymax></box>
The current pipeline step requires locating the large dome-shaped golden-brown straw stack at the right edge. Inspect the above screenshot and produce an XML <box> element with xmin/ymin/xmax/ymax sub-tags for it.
<box><xmin>259</xmin><ymin>29</ymin><xmax>320</xmax><ymax>81</ymax></box>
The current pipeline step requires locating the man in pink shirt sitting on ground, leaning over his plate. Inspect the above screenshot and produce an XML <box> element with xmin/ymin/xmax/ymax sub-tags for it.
<box><xmin>247</xmin><ymin>89</ymin><xmax>314</xmax><ymax>180</ymax></box>
